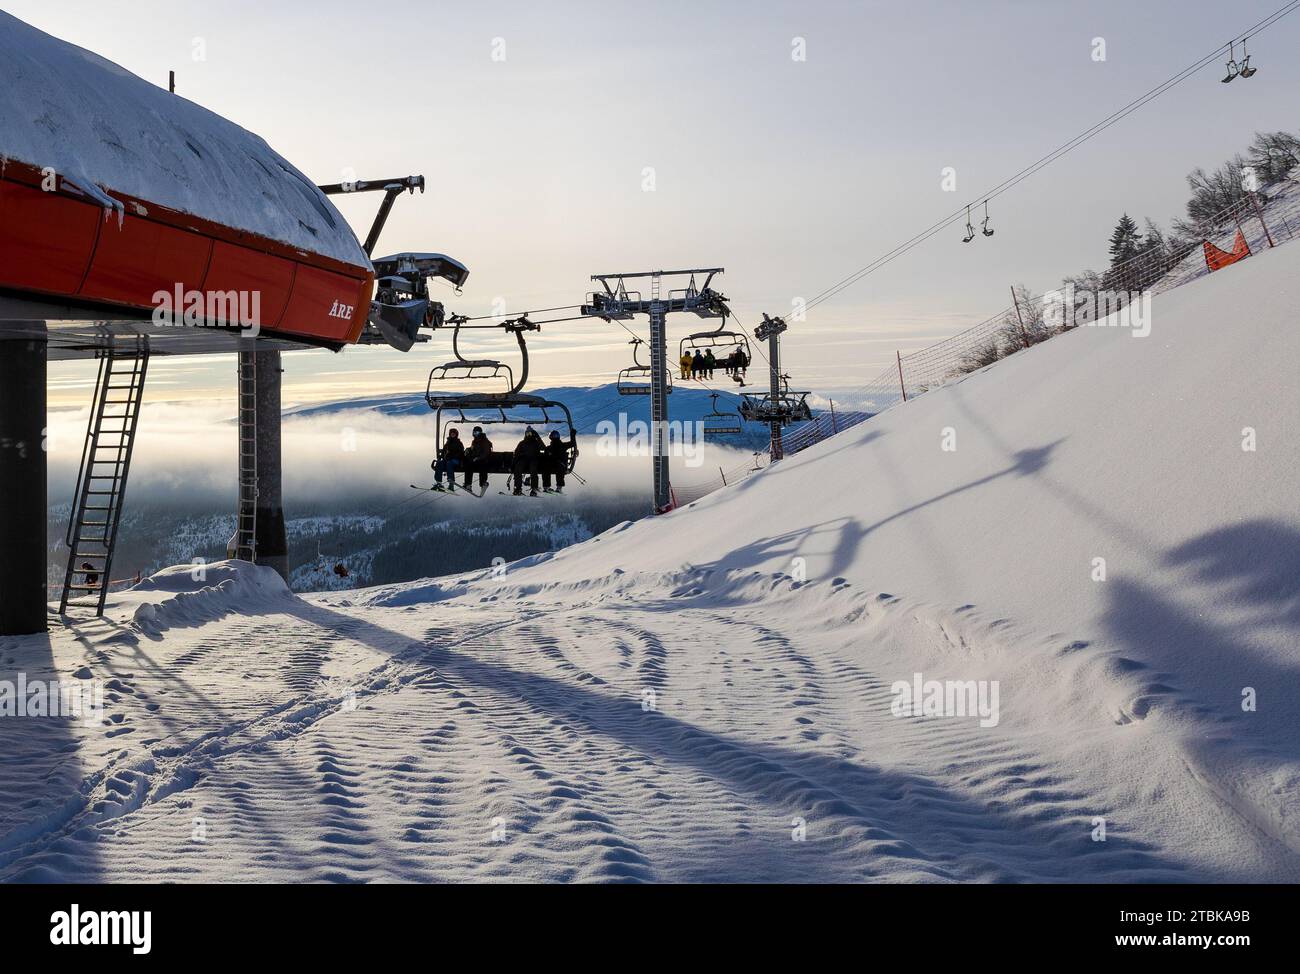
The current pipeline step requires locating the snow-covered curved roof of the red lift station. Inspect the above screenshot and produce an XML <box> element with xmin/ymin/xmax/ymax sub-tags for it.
<box><xmin>0</xmin><ymin>10</ymin><xmax>369</xmax><ymax>267</ymax></box>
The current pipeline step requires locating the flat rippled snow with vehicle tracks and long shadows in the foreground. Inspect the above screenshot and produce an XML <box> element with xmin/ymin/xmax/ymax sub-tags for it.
<box><xmin>0</xmin><ymin>569</ymin><xmax>1248</xmax><ymax>882</ymax></box>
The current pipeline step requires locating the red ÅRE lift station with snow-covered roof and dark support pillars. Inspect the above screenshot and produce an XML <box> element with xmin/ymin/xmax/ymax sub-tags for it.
<box><xmin>0</xmin><ymin>12</ymin><xmax>447</xmax><ymax>635</ymax></box>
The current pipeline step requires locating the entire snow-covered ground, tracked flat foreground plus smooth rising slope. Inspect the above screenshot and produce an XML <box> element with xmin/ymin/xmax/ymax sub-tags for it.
<box><xmin>0</xmin><ymin>241</ymin><xmax>1300</xmax><ymax>882</ymax></box>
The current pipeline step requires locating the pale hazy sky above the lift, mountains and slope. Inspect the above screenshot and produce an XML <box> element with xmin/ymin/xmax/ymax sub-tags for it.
<box><xmin>15</xmin><ymin>0</ymin><xmax>1300</xmax><ymax>404</ymax></box>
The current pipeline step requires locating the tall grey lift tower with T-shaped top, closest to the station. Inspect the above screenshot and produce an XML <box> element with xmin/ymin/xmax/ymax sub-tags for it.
<box><xmin>582</xmin><ymin>267</ymin><xmax>729</xmax><ymax>514</ymax></box>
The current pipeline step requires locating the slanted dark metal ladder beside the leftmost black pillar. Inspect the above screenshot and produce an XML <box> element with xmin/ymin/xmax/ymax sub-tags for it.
<box><xmin>59</xmin><ymin>336</ymin><xmax>150</xmax><ymax>615</ymax></box>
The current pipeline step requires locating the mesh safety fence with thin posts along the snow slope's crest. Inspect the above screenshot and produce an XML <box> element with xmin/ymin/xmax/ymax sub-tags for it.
<box><xmin>673</xmin><ymin>187</ymin><xmax>1297</xmax><ymax>506</ymax></box>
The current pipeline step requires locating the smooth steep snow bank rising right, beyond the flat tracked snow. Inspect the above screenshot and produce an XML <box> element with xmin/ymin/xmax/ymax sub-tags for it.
<box><xmin>486</xmin><ymin>246</ymin><xmax>1300</xmax><ymax>863</ymax></box>
